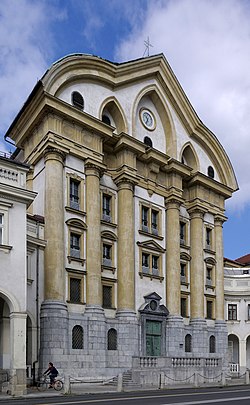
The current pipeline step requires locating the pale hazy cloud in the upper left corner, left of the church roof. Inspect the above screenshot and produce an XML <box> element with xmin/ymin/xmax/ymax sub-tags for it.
<box><xmin>0</xmin><ymin>0</ymin><xmax>64</xmax><ymax>150</ymax></box>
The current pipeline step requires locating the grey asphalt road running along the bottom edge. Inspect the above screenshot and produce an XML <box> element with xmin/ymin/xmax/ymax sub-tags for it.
<box><xmin>0</xmin><ymin>386</ymin><xmax>250</xmax><ymax>405</ymax></box>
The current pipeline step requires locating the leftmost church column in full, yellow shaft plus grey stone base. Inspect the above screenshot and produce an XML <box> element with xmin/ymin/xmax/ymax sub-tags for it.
<box><xmin>39</xmin><ymin>148</ymin><xmax>68</xmax><ymax>370</ymax></box>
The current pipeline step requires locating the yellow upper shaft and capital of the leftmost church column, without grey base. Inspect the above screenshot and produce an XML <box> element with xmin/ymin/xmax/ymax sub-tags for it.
<box><xmin>44</xmin><ymin>148</ymin><xmax>65</xmax><ymax>301</ymax></box>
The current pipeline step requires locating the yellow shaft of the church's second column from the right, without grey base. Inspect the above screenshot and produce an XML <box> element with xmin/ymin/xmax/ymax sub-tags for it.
<box><xmin>189</xmin><ymin>207</ymin><xmax>205</xmax><ymax>320</ymax></box>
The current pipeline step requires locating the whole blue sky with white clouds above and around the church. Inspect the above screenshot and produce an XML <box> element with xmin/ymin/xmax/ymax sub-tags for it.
<box><xmin>0</xmin><ymin>0</ymin><xmax>250</xmax><ymax>259</ymax></box>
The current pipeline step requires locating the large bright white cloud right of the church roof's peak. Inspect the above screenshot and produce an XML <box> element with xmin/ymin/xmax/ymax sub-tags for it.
<box><xmin>116</xmin><ymin>0</ymin><xmax>250</xmax><ymax>209</ymax></box>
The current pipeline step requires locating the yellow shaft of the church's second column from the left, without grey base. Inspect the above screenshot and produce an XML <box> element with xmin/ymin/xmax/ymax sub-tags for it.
<box><xmin>85</xmin><ymin>162</ymin><xmax>103</xmax><ymax>312</ymax></box>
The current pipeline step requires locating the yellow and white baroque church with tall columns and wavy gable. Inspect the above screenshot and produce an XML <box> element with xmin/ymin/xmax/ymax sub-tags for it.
<box><xmin>0</xmin><ymin>54</ymin><xmax>238</xmax><ymax>392</ymax></box>
